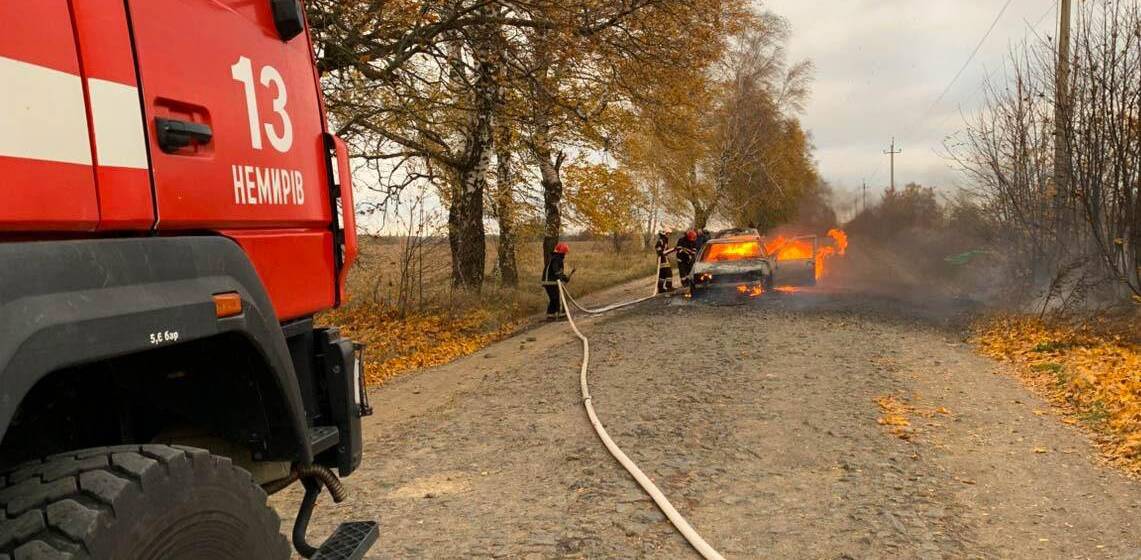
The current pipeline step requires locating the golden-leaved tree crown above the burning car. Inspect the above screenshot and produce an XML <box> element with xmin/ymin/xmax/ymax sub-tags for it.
<box><xmin>625</xmin><ymin>8</ymin><xmax>819</xmax><ymax>229</ymax></box>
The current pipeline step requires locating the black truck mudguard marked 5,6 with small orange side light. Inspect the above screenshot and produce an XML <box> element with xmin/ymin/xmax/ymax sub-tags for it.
<box><xmin>0</xmin><ymin>236</ymin><xmax>313</xmax><ymax>463</ymax></box>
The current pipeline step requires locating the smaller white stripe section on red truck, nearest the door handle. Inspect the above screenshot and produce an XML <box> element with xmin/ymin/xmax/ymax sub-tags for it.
<box><xmin>87</xmin><ymin>78</ymin><xmax>148</xmax><ymax>169</ymax></box>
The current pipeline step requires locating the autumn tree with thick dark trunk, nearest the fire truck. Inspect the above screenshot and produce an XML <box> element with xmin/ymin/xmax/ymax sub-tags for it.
<box><xmin>309</xmin><ymin>0</ymin><xmax>502</xmax><ymax>289</ymax></box>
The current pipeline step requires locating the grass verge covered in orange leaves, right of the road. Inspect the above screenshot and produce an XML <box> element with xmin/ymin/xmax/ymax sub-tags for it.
<box><xmin>973</xmin><ymin>315</ymin><xmax>1141</xmax><ymax>474</ymax></box>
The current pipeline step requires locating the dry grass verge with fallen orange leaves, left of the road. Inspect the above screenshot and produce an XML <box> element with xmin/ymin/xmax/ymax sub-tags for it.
<box><xmin>318</xmin><ymin>237</ymin><xmax>656</xmax><ymax>385</ymax></box>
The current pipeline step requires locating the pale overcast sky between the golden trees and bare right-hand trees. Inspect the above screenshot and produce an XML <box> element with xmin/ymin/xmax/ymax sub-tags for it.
<box><xmin>762</xmin><ymin>0</ymin><xmax>1057</xmax><ymax>209</ymax></box>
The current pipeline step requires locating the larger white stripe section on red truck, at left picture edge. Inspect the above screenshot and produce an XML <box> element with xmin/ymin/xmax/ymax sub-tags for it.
<box><xmin>0</xmin><ymin>56</ymin><xmax>91</xmax><ymax>165</ymax></box>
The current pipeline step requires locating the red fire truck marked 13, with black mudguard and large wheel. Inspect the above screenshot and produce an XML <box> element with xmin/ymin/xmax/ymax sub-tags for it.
<box><xmin>0</xmin><ymin>0</ymin><xmax>378</xmax><ymax>560</ymax></box>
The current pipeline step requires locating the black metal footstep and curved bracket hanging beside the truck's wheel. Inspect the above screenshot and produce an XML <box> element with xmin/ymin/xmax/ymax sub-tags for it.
<box><xmin>290</xmin><ymin>465</ymin><xmax>380</xmax><ymax>560</ymax></box>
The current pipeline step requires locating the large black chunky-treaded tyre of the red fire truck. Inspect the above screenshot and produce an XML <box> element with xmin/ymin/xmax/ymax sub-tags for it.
<box><xmin>0</xmin><ymin>445</ymin><xmax>290</xmax><ymax>560</ymax></box>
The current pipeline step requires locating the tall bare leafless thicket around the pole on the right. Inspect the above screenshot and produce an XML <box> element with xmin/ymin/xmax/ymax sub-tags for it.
<box><xmin>947</xmin><ymin>0</ymin><xmax>1141</xmax><ymax>300</ymax></box>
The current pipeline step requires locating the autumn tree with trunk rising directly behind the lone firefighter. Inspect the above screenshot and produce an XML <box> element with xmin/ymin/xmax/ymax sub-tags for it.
<box><xmin>506</xmin><ymin>0</ymin><xmax>744</xmax><ymax>258</ymax></box>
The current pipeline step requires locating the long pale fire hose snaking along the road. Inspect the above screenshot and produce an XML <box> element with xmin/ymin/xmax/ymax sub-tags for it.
<box><xmin>559</xmin><ymin>282</ymin><xmax>725</xmax><ymax>560</ymax></box>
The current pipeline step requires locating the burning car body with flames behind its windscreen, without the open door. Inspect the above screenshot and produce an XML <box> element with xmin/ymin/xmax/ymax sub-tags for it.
<box><xmin>689</xmin><ymin>232</ymin><xmax>776</xmax><ymax>298</ymax></box>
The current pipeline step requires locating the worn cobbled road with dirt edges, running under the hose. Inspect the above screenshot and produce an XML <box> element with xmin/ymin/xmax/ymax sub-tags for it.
<box><xmin>273</xmin><ymin>284</ymin><xmax>1141</xmax><ymax>560</ymax></box>
